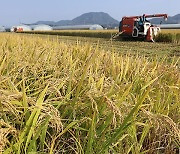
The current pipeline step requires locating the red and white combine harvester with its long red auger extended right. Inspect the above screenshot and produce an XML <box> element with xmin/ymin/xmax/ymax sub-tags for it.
<box><xmin>112</xmin><ymin>14</ymin><xmax>168</xmax><ymax>42</ymax></box>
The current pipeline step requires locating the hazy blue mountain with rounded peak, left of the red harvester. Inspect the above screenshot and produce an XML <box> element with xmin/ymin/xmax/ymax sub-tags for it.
<box><xmin>34</xmin><ymin>12</ymin><xmax>119</xmax><ymax>27</ymax></box>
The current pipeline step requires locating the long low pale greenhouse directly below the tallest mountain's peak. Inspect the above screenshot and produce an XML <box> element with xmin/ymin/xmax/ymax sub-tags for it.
<box><xmin>53</xmin><ymin>25</ymin><xmax>103</xmax><ymax>30</ymax></box>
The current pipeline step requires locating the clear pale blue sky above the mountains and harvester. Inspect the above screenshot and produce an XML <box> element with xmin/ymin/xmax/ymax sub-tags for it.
<box><xmin>0</xmin><ymin>0</ymin><xmax>180</xmax><ymax>26</ymax></box>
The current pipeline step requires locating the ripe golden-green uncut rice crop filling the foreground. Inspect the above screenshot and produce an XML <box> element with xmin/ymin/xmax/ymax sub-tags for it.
<box><xmin>0</xmin><ymin>34</ymin><xmax>180</xmax><ymax>154</ymax></box>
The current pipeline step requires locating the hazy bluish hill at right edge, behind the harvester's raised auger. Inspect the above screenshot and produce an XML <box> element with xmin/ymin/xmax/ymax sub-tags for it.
<box><xmin>151</xmin><ymin>14</ymin><xmax>180</xmax><ymax>24</ymax></box>
